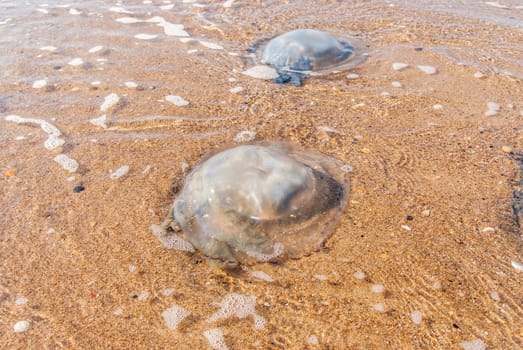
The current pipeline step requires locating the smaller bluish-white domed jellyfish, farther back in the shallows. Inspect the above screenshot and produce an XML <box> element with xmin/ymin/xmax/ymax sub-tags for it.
<box><xmin>260</xmin><ymin>29</ymin><xmax>363</xmax><ymax>86</ymax></box>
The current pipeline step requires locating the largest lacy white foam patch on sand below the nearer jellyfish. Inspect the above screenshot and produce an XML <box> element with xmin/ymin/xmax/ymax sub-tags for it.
<box><xmin>207</xmin><ymin>293</ymin><xmax>266</xmax><ymax>329</ymax></box>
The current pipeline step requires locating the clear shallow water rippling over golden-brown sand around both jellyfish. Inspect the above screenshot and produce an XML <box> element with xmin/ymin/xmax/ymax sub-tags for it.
<box><xmin>0</xmin><ymin>0</ymin><xmax>523</xmax><ymax>349</ymax></box>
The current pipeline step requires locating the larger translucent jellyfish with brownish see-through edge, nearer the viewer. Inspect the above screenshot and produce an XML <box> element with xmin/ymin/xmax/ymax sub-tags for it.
<box><xmin>167</xmin><ymin>142</ymin><xmax>349</xmax><ymax>267</ymax></box>
